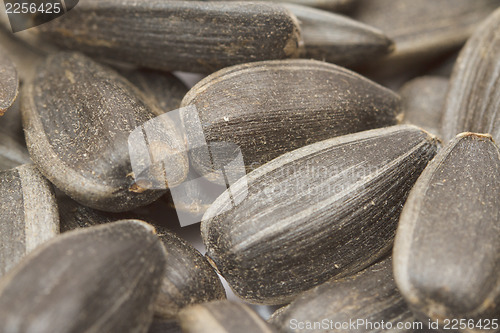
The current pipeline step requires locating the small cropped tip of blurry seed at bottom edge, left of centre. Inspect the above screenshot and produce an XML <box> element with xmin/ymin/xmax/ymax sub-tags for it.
<box><xmin>179</xmin><ymin>301</ymin><xmax>277</xmax><ymax>333</ymax></box>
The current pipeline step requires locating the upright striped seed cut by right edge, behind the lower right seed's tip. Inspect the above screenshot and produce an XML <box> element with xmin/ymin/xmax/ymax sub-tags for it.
<box><xmin>441</xmin><ymin>9</ymin><xmax>500</xmax><ymax>142</ymax></box>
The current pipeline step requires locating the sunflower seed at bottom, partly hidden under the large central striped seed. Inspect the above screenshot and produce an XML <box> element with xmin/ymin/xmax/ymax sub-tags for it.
<box><xmin>270</xmin><ymin>258</ymin><xmax>415</xmax><ymax>332</ymax></box>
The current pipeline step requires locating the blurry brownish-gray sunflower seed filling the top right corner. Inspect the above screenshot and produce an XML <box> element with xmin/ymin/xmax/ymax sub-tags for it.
<box><xmin>353</xmin><ymin>0</ymin><xmax>500</xmax><ymax>73</ymax></box>
